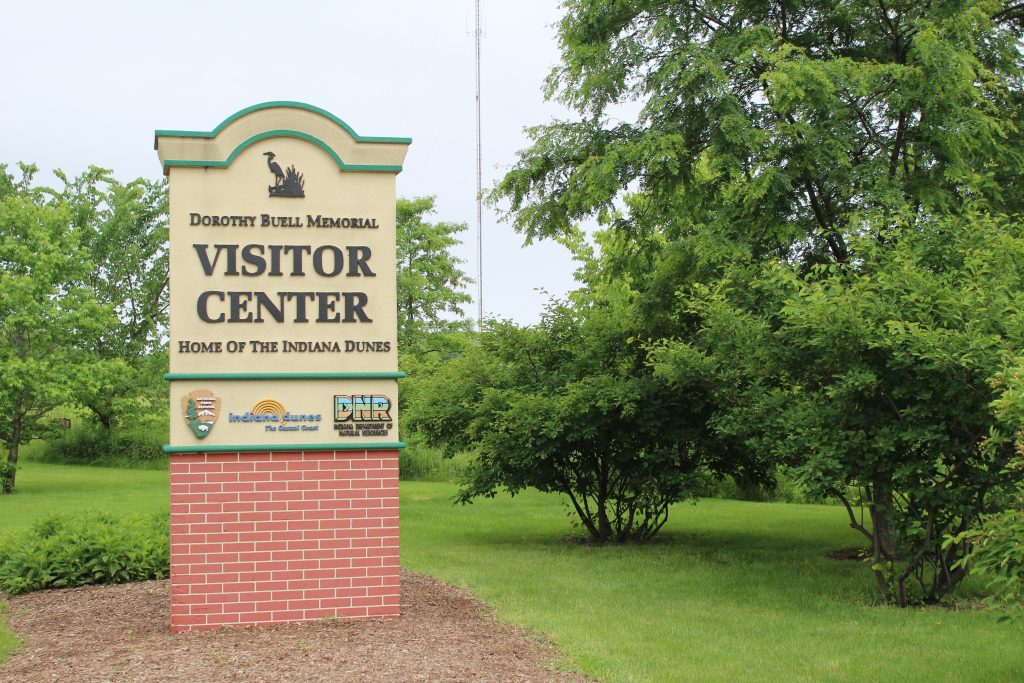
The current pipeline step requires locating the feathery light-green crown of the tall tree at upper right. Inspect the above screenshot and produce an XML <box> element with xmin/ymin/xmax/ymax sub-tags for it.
<box><xmin>494</xmin><ymin>0</ymin><xmax>1024</xmax><ymax>248</ymax></box>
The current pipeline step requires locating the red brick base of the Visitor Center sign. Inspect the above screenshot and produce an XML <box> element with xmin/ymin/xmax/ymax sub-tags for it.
<box><xmin>171</xmin><ymin>451</ymin><xmax>398</xmax><ymax>631</ymax></box>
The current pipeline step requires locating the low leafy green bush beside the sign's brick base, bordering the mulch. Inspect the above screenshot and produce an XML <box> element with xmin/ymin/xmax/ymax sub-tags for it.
<box><xmin>0</xmin><ymin>512</ymin><xmax>170</xmax><ymax>595</ymax></box>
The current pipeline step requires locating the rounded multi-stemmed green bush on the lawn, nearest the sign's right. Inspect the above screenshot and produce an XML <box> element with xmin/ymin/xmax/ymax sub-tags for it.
<box><xmin>407</xmin><ymin>290</ymin><xmax>763</xmax><ymax>543</ymax></box>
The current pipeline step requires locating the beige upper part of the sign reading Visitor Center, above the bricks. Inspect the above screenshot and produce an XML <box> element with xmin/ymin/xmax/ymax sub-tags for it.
<box><xmin>157</xmin><ymin>102</ymin><xmax>409</xmax><ymax>452</ymax></box>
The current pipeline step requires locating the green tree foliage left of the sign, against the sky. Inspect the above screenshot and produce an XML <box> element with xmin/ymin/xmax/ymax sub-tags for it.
<box><xmin>0</xmin><ymin>165</ymin><xmax>167</xmax><ymax>489</ymax></box>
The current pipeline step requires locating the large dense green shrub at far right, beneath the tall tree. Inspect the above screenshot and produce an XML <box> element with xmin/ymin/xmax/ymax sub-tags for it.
<box><xmin>653</xmin><ymin>214</ymin><xmax>1024</xmax><ymax>605</ymax></box>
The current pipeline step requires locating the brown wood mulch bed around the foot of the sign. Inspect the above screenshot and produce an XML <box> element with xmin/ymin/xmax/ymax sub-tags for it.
<box><xmin>0</xmin><ymin>570</ymin><xmax>587</xmax><ymax>683</ymax></box>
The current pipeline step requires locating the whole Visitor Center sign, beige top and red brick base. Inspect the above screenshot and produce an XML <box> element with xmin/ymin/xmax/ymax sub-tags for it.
<box><xmin>156</xmin><ymin>101</ymin><xmax>410</xmax><ymax>630</ymax></box>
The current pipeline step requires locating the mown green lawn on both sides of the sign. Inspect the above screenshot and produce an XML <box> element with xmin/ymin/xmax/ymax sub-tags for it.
<box><xmin>0</xmin><ymin>463</ymin><xmax>1024</xmax><ymax>682</ymax></box>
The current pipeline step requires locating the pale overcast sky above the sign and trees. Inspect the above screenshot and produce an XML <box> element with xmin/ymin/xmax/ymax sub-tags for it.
<box><xmin>0</xmin><ymin>0</ymin><xmax>573</xmax><ymax>324</ymax></box>
